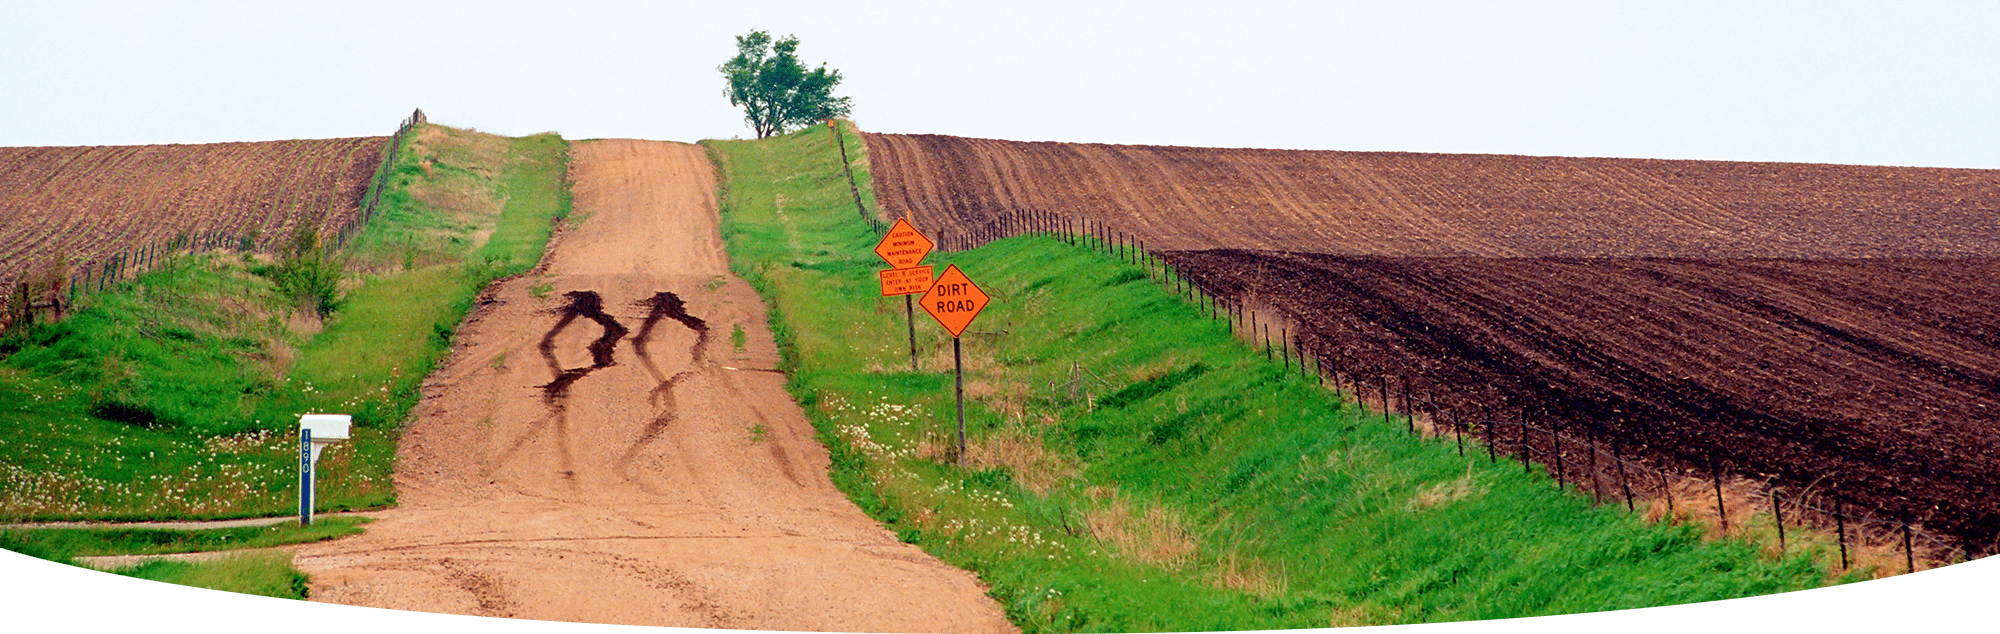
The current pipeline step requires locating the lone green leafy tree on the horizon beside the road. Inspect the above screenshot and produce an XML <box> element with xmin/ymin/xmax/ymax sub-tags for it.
<box><xmin>716</xmin><ymin>30</ymin><xmax>850</xmax><ymax>138</ymax></box>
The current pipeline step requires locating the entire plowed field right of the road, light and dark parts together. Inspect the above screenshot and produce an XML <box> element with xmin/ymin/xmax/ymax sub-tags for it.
<box><xmin>868</xmin><ymin>134</ymin><xmax>2000</xmax><ymax>554</ymax></box>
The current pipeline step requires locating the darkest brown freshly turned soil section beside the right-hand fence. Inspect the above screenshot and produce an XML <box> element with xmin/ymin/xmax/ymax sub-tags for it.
<box><xmin>1166</xmin><ymin>250</ymin><xmax>2000</xmax><ymax>552</ymax></box>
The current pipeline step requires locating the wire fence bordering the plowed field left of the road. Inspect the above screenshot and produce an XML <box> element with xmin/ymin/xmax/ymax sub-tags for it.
<box><xmin>0</xmin><ymin>108</ymin><xmax>426</xmax><ymax>330</ymax></box>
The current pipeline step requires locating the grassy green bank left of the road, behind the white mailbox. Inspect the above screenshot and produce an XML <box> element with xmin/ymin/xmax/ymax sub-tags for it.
<box><xmin>0</xmin><ymin>126</ymin><xmax>568</xmax><ymax>522</ymax></box>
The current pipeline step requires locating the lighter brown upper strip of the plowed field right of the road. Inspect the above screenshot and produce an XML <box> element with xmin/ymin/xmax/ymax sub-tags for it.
<box><xmin>864</xmin><ymin>134</ymin><xmax>2000</xmax><ymax>258</ymax></box>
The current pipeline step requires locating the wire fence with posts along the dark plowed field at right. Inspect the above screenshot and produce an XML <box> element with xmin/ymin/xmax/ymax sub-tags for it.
<box><xmin>936</xmin><ymin>210</ymin><xmax>1984</xmax><ymax>572</ymax></box>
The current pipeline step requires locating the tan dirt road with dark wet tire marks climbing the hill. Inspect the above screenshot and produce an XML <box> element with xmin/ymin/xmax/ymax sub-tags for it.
<box><xmin>296</xmin><ymin>140</ymin><xmax>1014</xmax><ymax>632</ymax></box>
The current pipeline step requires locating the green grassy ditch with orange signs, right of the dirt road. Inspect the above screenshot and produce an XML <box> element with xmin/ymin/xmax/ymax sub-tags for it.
<box><xmin>706</xmin><ymin>128</ymin><xmax>1860</xmax><ymax>632</ymax></box>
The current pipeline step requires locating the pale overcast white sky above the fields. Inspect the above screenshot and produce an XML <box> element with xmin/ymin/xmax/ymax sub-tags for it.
<box><xmin>0</xmin><ymin>0</ymin><xmax>2000</xmax><ymax>168</ymax></box>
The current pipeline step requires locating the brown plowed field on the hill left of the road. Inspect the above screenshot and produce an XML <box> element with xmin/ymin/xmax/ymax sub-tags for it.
<box><xmin>0</xmin><ymin>136</ymin><xmax>388</xmax><ymax>282</ymax></box>
